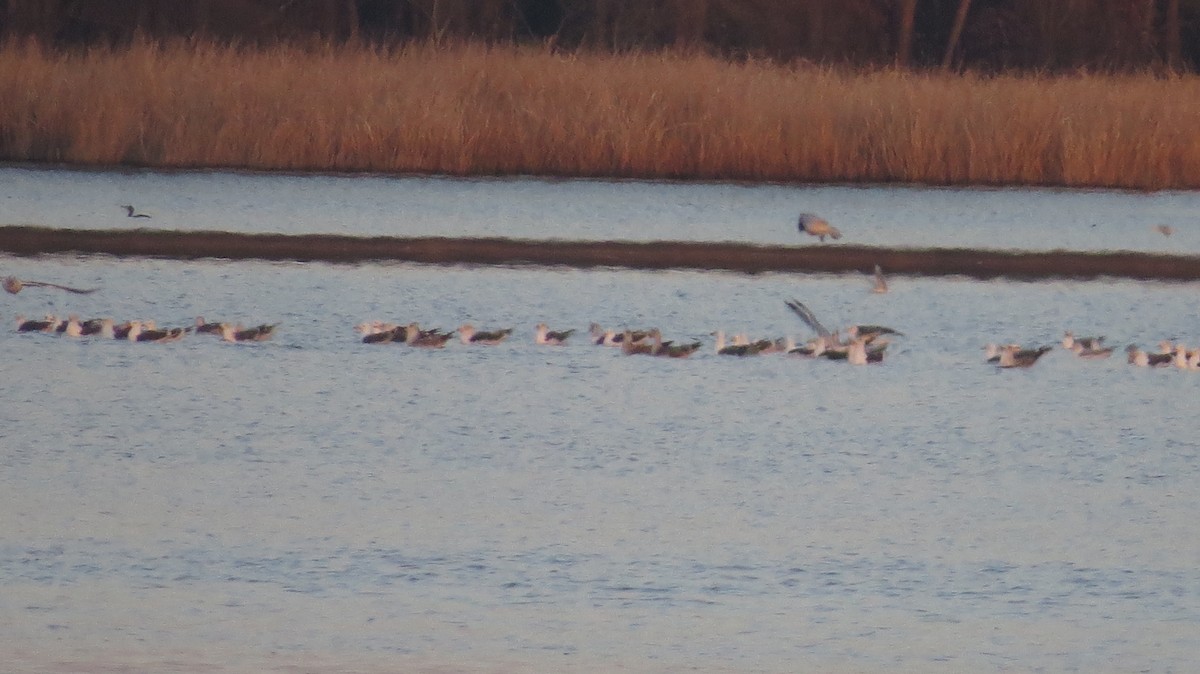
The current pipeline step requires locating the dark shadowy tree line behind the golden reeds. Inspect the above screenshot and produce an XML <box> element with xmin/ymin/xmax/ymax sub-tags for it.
<box><xmin>0</xmin><ymin>0</ymin><xmax>1200</xmax><ymax>72</ymax></box>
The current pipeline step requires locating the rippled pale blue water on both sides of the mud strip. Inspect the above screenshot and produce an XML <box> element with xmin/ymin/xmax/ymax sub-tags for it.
<box><xmin>0</xmin><ymin>168</ymin><xmax>1200</xmax><ymax>673</ymax></box>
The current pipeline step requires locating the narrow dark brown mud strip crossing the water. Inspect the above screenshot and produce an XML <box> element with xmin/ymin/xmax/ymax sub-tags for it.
<box><xmin>0</xmin><ymin>225</ymin><xmax>1200</xmax><ymax>281</ymax></box>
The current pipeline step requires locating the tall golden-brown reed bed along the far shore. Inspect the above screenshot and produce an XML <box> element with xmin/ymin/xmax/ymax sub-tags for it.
<box><xmin>0</xmin><ymin>42</ymin><xmax>1200</xmax><ymax>189</ymax></box>
